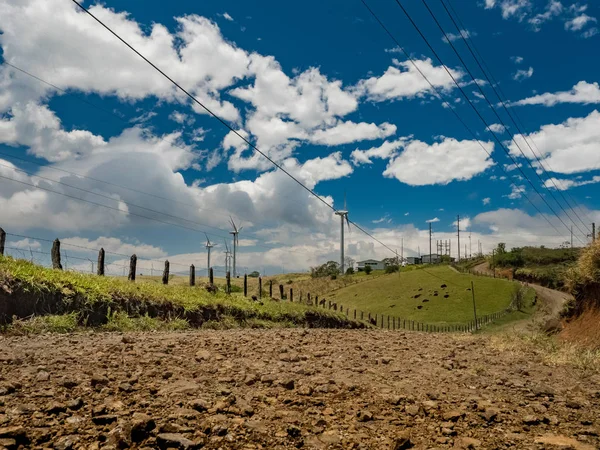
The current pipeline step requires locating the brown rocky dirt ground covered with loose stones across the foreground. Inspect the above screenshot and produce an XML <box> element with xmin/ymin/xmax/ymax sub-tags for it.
<box><xmin>0</xmin><ymin>329</ymin><xmax>600</xmax><ymax>450</ymax></box>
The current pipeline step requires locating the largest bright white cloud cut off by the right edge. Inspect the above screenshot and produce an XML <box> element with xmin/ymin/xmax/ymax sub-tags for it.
<box><xmin>509</xmin><ymin>111</ymin><xmax>600</xmax><ymax>174</ymax></box>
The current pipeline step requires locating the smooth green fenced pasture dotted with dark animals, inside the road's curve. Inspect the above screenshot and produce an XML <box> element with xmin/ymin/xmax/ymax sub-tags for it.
<box><xmin>327</xmin><ymin>266</ymin><xmax>517</xmax><ymax>324</ymax></box>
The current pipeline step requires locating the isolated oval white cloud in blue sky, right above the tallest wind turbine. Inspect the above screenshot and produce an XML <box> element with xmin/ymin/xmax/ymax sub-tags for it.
<box><xmin>383</xmin><ymin>138</ymin><xmax>494</xmax><ymax>186</ymax></box>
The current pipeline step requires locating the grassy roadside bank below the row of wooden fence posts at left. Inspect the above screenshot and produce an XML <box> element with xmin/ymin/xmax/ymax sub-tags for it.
<box><xmin>0</xmin><ymin>257</ymin><xmax>359</xmax><ymax>327</ymax></box>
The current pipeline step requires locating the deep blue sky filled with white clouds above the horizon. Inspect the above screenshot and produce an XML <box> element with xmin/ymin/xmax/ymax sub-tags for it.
<box><xmin>0</xmin><ymin>0</ymin><xmax>600</xmax><ymax>273</ymax></box>
